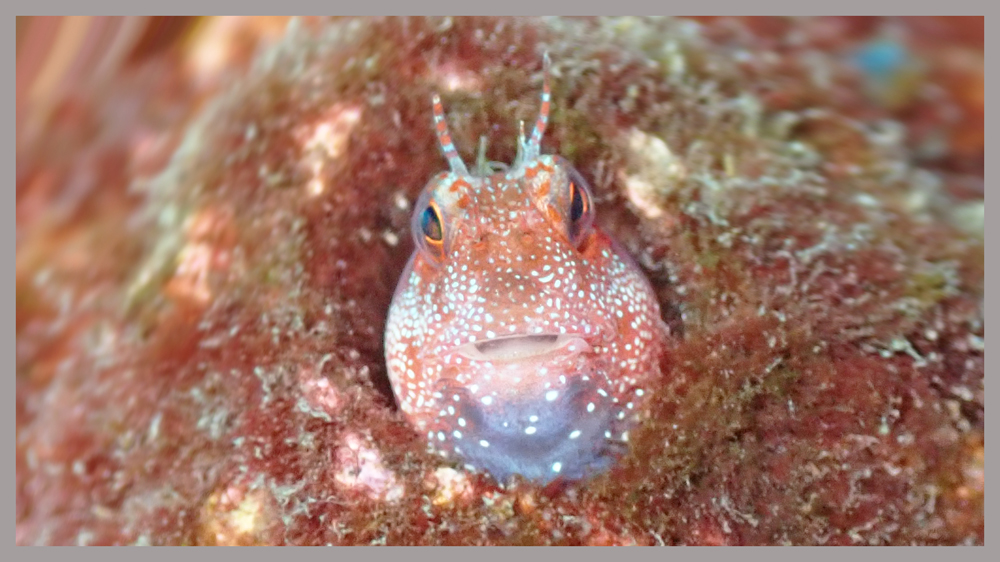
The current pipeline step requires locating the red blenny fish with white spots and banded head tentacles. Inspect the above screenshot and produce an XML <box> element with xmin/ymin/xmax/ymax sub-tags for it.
<box><xmin>385</xmin><ymin>55</ymin><xmax>668</xmax><ymax>483</ymax></box>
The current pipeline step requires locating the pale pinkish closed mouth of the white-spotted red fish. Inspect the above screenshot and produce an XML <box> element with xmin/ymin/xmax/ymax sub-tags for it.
<box><xmin>454</xmin><ymin>334</ymin><xmax>592</xmax><ymax>363</ymax></box>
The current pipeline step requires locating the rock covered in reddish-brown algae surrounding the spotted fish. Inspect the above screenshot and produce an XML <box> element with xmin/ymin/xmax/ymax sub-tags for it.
<box><xmin>16</xmin><ymin>18</ymin><xmax>985</xmax><ymax>544</ymax></box>
